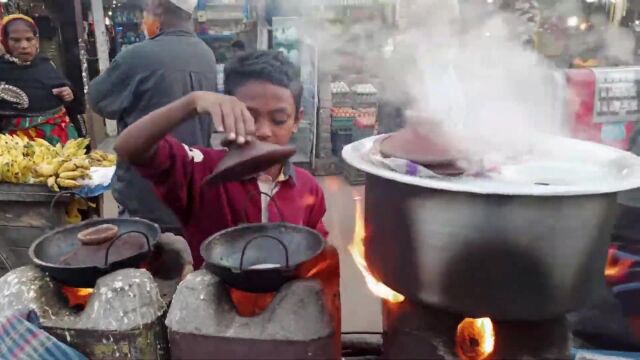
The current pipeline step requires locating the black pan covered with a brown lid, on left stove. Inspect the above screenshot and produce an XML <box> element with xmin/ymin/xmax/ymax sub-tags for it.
<box><xmin>29</xmin><ymin>193</ymin><xmax>160</xmax><ymax>288</ymax></box>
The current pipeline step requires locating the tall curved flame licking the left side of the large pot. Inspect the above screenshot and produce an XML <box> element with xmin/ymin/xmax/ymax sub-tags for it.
<box><xmin>349</xmin><ymin>198</ymin><xmax>405</xmax><ymax>303</ymax></box>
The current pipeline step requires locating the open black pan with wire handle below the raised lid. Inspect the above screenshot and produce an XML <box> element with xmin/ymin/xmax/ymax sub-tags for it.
<box><xmin>200</xmin><ymin>193</ymin><xmax>326</xmax><ymax>293</ymax></box>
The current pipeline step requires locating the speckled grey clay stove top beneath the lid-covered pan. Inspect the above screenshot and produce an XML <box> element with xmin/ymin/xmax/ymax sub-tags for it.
<box><xmin>0</xmin><ymin>266</ymin><xmax>166</xmax><ymax>331</ymax></box>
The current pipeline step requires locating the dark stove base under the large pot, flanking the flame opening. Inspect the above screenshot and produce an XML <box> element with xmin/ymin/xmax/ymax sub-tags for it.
<box><xmin>383</xmin><ymin>301</ymin><xmax>571</xmax><ymax>360</ymax></box>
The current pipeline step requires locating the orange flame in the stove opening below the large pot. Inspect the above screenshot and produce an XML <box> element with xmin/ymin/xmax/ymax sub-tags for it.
<box><xmin>456</xmin><ymin>318</ymin><xmax>496</xmax><ymax>360</ymax></box>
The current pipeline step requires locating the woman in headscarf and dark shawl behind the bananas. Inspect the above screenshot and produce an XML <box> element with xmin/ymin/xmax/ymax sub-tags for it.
<box><xmin>0</xmin><ymin>15</ymin><xmax>78</xmax><ymax>145</ymax></box>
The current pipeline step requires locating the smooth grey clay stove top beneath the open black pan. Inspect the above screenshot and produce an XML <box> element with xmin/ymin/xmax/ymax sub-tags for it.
<box><xmin>166</xmin><ymin>270</ymin><xmax>334</xmax><ymax>341</ymax></box>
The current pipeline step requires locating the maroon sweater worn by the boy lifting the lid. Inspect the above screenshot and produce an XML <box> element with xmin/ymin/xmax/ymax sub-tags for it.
<box><xmin>137</xmin><ymin>137</ymin><xmax>328</xmax><ymax>269</ymax></box>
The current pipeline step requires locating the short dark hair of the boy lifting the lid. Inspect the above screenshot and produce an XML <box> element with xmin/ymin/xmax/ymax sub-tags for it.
<box><xmin>224</xmin><ymin>50</ymin><xmax>302</xmax><ymax>111</ymax></box>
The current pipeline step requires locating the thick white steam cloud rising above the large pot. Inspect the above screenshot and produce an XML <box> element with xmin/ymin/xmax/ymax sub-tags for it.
<box><xmin>284</xmin><ymin>0</ymin><xmax>635</xmax><ymax>143</ymax></box>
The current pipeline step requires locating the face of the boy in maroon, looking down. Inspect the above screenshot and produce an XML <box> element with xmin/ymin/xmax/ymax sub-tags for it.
<box><xmin>234</xmin><ymin>81</ymin><xmax>302</xmax><ymax>145</ymax></box>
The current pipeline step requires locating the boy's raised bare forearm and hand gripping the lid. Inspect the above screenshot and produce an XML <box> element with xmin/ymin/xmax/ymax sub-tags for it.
<box><xmin>115</xmin><ymin>92</ymin><xmax>255</xmax><ymax>165</ymax></box>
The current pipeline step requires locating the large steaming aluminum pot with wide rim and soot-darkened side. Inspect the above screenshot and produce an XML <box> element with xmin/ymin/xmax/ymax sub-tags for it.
<box><xmin>343</xmin><ymin>138</ymin><xmax>640</xmax><ymax>320</ymax></box>
